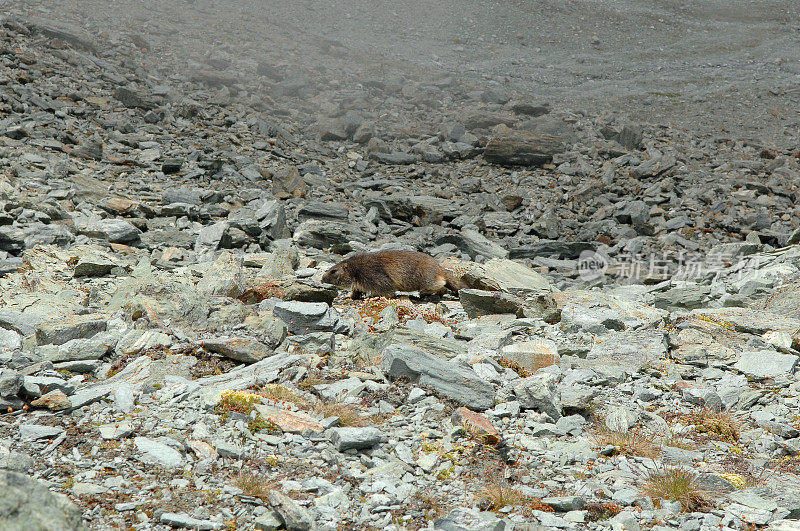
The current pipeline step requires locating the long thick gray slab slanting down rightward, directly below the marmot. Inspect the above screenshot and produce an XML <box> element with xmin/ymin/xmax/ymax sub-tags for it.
<box><xmin>382</xmin><ymin>344</ymin><xmax>494</xmax><ymax>411</ymax></box>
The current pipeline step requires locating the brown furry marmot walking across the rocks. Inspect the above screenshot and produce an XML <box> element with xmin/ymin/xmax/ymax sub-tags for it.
<box><xmin>322</xmin><ymin>251</ymin><xmax>466</xmax><ymax>299</ymax></box>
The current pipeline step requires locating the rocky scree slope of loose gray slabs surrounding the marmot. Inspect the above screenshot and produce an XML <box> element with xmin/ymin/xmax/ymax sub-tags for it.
<box><xmin>0</xmin><ymin>9</ymin><xmax>800</xmax><ymax>529</ymax></box>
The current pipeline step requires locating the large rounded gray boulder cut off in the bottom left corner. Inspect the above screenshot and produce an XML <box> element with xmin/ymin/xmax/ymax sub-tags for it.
<box><xmin>0</xmin><ymin>470</ymin><xmax>86</xmax><ymax>531</ymax></box>
